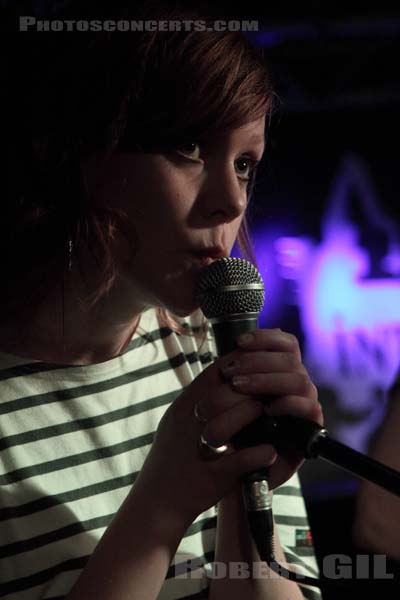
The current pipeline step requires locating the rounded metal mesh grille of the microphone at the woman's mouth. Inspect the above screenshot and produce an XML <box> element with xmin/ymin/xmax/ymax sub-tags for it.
<box><xmin>196</xmin><ymin>257</ymin><xmax>265</xmax><ymax>319</ymax></box>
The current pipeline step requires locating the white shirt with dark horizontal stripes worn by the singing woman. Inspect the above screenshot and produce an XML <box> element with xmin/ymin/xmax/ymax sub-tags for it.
<box><xmin>0</xmin><ymin>309</ymin><xmax>320</xmax><ymax>600</ymax></box>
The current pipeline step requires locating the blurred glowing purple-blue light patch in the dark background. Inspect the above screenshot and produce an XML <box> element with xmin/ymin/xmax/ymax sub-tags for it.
<box><xmin>234</xmin><ymin>155</ymin><xmax>400</xmax><ymax>464</ymax></box>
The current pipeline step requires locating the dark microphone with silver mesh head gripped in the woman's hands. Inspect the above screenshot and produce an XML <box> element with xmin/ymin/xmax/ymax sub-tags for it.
<box><xmin>196</xmin><ymin>258</ymin><xmax>274</xmax><ymax>561</ymax></box>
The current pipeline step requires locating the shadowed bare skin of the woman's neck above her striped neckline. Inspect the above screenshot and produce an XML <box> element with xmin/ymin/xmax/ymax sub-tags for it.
<box><xmin>0</xmin><ymin>274</ymin><xmax>148</xmax><ymax>365</ymax></box>
